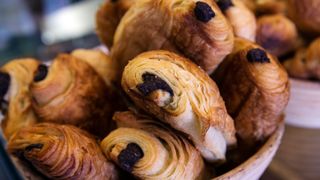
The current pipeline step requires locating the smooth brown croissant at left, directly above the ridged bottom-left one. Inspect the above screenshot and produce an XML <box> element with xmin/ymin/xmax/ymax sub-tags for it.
<box><xmin>31</xmin><ymin>53</ymin><xmax>114</xmax><ymax>137</ymax></box>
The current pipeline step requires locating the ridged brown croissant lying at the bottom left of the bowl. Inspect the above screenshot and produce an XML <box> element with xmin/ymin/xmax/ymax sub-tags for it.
<box><xmin>8</xmin><ymin>123</ymin><xmax>118</xmax><ymax>179</ymax></box>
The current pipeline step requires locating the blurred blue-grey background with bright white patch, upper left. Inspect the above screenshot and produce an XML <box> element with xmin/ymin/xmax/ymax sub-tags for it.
<box><xmin>0</xmin><ymin>0</ymin><xmax>103</xmax><ymax>65</ymax></box>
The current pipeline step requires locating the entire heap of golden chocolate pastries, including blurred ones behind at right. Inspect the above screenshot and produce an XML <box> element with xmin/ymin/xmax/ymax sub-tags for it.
<box><xmin>0</xmin><ymin>0</ymin><xmax>320</xmax><ymax>179</ymax></box>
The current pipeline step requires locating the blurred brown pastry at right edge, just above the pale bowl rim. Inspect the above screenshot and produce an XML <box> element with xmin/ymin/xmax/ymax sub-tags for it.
<box><xmin>284</xmin><ymin>38</ymin><xmax>320</xmax><ymax>80</ymax></box>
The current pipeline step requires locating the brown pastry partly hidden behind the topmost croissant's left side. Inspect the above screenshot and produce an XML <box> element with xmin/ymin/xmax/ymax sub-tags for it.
<box><xmin>96</xmin><ymin>0</ymin><xmax>137</xmax><ymax>48</ymax></box>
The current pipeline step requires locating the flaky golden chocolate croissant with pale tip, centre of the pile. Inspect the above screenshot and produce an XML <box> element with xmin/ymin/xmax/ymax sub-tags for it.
<box><xmin>121</xmin><ymin>50</ymin><xmax>236</xmax><ymax>162</ymax></box>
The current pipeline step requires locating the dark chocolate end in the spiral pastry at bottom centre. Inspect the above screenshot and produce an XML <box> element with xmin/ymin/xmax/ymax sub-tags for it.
<box><xmin>118</xmin><ymin>143</ymin><xmax>144</xmax><ymax>172</ymax></box>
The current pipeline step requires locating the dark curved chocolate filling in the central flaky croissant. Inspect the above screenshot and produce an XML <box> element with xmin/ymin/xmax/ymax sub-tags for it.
<box><xmin>137</xmin><ymin>72</ymin><xmax>173</xmax><ymax>96</ymax></box>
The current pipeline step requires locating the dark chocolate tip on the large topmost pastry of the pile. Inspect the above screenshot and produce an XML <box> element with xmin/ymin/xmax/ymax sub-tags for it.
<box><xmin>194</xmin><ymin>1</ymin><xmax>215</xmax><ymax>23</ymax></box>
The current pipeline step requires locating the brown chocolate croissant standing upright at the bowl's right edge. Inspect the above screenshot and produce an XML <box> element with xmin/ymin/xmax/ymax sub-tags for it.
<box><xmin>212</xmin><ymin>38</ymin><xmax>289</xmax><ymax>144</ymax></box>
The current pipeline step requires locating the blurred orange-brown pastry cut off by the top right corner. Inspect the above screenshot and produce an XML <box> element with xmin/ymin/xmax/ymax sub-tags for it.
<box><xmin>288</xmin><ymin>0</ymin><xmax>320</xmax><ymax>35</ymax></box>
